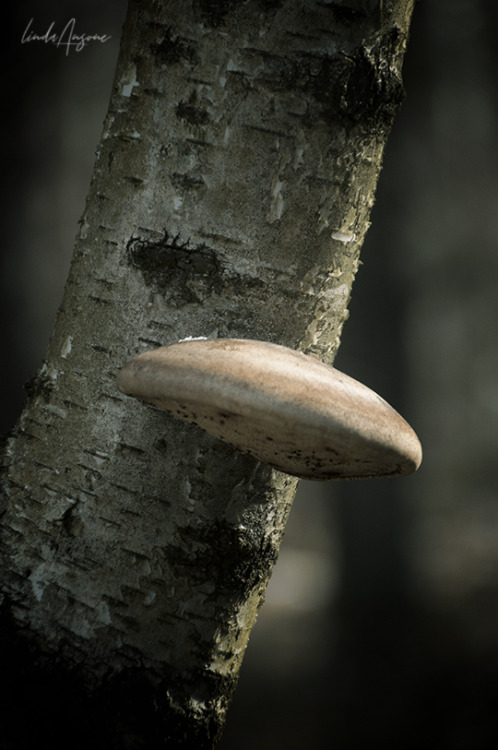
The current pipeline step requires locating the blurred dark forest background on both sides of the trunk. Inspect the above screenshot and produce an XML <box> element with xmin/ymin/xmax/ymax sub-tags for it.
<box><xmin>0</xmin><ymin>0</ymin><xmax>498</xmax><ymax>750</ymax></box>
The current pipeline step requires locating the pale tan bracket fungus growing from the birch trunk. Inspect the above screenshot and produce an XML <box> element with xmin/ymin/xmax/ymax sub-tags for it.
<box><xmin>117</xmin><ymin>339</ymin><xmax>422</xmax><ymax>480</ymax></box>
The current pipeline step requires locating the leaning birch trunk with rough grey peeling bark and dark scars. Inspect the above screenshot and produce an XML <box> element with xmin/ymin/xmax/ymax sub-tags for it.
<box><xmin>1</xmin><ymin>0</ymin><xmax>412</xmax><ymax>749</ymax></box>
